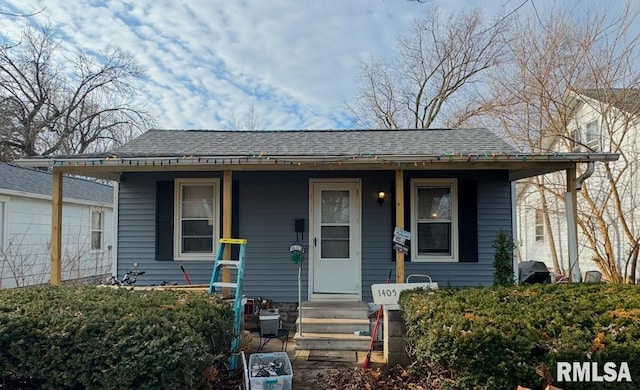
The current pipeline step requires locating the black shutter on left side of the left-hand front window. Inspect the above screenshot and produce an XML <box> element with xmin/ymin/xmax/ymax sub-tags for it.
<box><xmin>156</xmin><ymin>181</ymin><xmax>174</xmax><ymax>261</ymax></box>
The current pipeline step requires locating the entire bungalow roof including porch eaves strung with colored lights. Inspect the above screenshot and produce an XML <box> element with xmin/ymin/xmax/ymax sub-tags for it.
<box><xmin>18</xmin><ymin>129</ymin><xmax>618</xmax><ymax>181</ymax></box>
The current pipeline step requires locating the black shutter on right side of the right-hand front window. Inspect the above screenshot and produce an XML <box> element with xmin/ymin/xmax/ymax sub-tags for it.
<box><xmin>458</xmin><ymin>181</ymin><xmax>478</xmax><ymax>263</ymax></box>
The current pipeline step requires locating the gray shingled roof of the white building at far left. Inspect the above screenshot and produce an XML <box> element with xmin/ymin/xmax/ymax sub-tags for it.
<box><xmin>0</xmin><ymin>163</ymin><xmax>113</xmax><ymax>203</ymax></box>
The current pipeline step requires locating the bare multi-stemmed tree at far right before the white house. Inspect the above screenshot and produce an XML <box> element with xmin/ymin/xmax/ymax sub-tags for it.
<box><xmin>466</xmin><ymin>2</ymin><xmax>640</xmax><ymax>283</ymax></box>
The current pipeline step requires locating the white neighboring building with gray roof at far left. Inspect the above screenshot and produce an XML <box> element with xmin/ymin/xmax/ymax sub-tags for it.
<box><xmin>0</xmin><ymin>163</ymin><xmax>114</xmax><ymax>288</ymax></box>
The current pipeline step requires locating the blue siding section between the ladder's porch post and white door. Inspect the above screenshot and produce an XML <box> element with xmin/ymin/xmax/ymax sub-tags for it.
<box><xmin>234</xmin><ymin>172</ymin><xmax>309</xmax><ymax>302</ymax></box>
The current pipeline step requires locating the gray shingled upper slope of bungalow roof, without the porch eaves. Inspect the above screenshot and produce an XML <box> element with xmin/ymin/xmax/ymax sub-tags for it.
<box><xmin>108</xmin><ymin>129</ymin><xmax>517</xmax><ymax>158</ymax></box>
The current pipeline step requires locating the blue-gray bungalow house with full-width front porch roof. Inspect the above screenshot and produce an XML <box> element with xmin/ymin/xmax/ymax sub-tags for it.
<box><xmin>20</xmin><ymin>129</ymin><xmax>617</xmax><ymax>349</ymax></box>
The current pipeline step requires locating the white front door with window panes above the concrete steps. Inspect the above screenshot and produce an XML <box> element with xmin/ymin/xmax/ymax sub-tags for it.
<box><xmin>309</xmin><ymin>179</ymin><xmax>362</xmax><ymax>300</ymax></box>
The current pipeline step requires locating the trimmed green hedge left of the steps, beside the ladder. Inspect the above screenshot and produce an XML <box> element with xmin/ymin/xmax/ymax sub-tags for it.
<box><xmin>0</xmin><ymin>286</ymin><xmax>233</xmax><ymax>389</ymax></box>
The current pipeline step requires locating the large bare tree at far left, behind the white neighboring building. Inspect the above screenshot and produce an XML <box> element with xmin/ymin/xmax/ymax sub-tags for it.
<box><xmin>0</xmin><ymin>26</ymin><xmax>153</xmax><ymax>160</ymax></box>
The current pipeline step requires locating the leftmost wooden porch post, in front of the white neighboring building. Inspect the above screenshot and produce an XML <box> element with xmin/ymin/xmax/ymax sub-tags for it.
<box><xmin>49</xmin><ymin>168</ymin><xmax>63</xmax><ymax>286</ymax></box>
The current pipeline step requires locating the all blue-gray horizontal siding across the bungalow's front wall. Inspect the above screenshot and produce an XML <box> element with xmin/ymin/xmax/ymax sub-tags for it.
<box><xmin>118</xmin><ymin>171</ymin><xmax>511</xmax><ymax>302</ymax></box>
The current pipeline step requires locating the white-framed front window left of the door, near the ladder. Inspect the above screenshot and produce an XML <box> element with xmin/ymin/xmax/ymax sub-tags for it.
<box><xmin>175</xmin><ymin>179</ymin><xmax>219</xmax><ymax>260</ymax></box>
